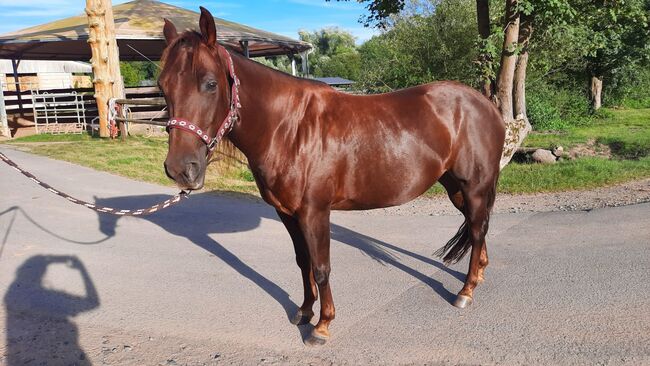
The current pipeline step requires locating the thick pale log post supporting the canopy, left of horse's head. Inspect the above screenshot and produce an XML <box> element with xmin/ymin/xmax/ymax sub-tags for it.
<box><xmin>86</xmin><ymin>0</ymin><xmax>124</xmax><ymax>137</ymax></box>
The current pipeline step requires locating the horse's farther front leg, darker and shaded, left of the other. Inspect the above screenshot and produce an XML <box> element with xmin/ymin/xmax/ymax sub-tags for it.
<box><xmin>277</xmin><ymin>211</ymin><xmax>318</xmax><ymax>325</ymax></box>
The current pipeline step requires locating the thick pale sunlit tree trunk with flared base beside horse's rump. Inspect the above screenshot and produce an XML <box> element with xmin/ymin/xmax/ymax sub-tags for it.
<box><xmin>497</xmin><ymin>0</ymin><xmax>530</xmax><ymax>169</ymax></box>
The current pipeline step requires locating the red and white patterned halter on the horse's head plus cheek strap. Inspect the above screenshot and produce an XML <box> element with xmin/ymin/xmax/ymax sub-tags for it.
<box><xmin>167</xmin><ymin>45</ymin><xmax>241</xmax><ymax>155</ymax></box>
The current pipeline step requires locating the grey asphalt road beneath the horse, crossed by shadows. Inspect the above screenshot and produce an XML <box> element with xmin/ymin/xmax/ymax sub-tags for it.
<box><xmin>0</xmin><ymin>147</ymin><xmax>650</xmax><ymax>365</ymax></box>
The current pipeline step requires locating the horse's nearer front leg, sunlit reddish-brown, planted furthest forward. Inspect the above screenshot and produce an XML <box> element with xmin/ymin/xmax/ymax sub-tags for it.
<box><xmin>298</xmin><ymin>207</ymin><xmax>335</xmax><ymax>344</ymax></box>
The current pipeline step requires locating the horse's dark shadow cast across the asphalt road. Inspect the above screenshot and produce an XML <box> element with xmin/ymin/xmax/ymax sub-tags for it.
<box><xmin>95</xmin><ymin>193</ymin><xmax>465</xmax><ymax>336</ymax></box>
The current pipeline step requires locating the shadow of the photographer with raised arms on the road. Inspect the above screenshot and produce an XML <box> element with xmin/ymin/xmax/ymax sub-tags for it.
<box><xmin>4</xmin><ymin>255</ymin><xmax>99</xmax><ymax>366</ymax></box>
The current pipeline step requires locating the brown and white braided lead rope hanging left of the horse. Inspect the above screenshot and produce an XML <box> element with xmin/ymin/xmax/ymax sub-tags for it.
<box><xmin>0</xmin><ymin>152</ymin><xmax>189</xmax><ymax>216</ymax></box>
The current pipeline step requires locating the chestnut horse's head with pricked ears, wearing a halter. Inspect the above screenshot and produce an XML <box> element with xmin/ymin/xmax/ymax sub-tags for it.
<box><xmin>158</xmin><ymin>8</ymin><xmax>232</xmax><ymax>190</ymax></box>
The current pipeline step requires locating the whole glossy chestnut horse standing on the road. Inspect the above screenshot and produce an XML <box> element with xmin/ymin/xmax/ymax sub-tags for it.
<box><xmin>159</xmin><ymin>8</ymin><xmax>505</xmax><ymax>344</ymax></box>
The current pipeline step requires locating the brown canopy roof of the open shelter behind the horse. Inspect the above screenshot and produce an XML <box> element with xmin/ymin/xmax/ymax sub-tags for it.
<box><xmin>0</xmin><ymin>0</ymin><xmax>311</xmax><ymax>60</ymax></box>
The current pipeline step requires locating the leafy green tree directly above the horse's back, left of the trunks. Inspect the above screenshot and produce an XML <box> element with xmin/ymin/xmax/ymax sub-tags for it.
<box><xmin>357</xmin><ymin>0</ymin><xmax>478</xmax><ymax>93</ymax></box>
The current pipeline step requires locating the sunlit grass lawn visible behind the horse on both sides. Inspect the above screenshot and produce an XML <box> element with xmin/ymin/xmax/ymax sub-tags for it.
<box><xmin>7</xmin><ymin>109</ymin><xmax>650</xmax><ymax>195</ymax></box>
